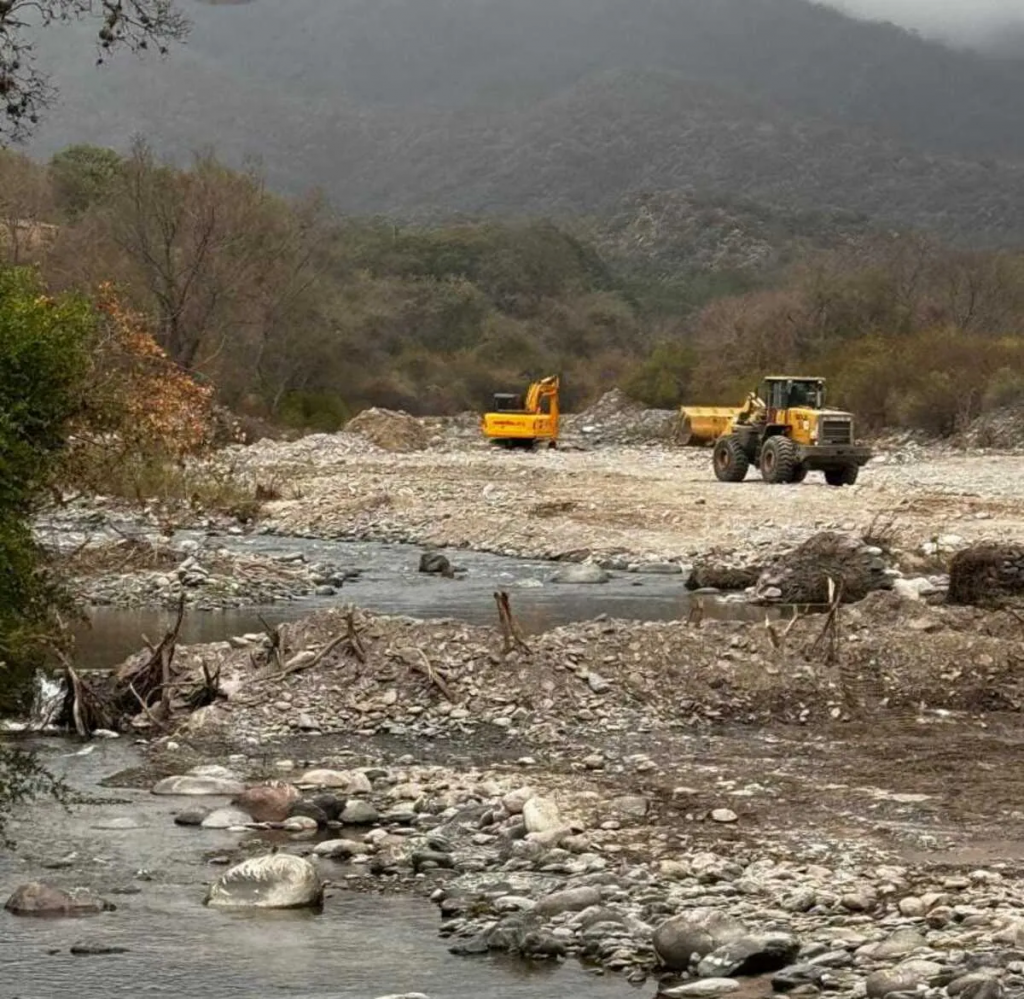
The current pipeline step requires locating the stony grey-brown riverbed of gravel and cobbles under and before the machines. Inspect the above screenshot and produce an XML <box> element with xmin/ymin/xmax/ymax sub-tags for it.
<box><xmin>14</xmin><ymin>414</ymin><xmax>1024</xmax><ymax>999</ymax></box>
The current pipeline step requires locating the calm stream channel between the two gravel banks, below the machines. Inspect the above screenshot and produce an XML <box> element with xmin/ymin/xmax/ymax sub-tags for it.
<box><xmin>76</xmin><ymin>535</ymin><xmax>778</xmax><ymax>668</ymax></box>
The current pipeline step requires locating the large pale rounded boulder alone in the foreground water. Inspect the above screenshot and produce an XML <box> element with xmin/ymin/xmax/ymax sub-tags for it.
<box><xmin>206</xmin><ymin>854</ymin><xmax>324</xmax><ymax>909</ymax></box>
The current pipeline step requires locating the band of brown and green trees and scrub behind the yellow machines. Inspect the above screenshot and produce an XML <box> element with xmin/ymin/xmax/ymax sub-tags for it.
<box><xmin>0</xmin><ymin>144</ymin><xmax>1024</xmax><ymax>434</ymax></box>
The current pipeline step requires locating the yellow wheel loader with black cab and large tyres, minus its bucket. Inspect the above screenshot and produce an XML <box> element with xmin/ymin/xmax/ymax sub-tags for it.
<box><xmin>712</xmin><ymin>375</ymin><xmax>871</xmax><ymax>486</ymax></box>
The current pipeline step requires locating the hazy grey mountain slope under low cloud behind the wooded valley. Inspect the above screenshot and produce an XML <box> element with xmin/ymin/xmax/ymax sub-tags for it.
<box><xmin>18</xmin><ymin>0</ymin><xmax>1024</xmax><ymax>245</ymax></box>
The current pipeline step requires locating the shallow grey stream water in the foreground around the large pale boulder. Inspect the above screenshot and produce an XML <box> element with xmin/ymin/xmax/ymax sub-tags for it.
<box><xmin>0</xmin><ymin>739</ymin><xmax>638</xmax><ymax>999</ymax></box>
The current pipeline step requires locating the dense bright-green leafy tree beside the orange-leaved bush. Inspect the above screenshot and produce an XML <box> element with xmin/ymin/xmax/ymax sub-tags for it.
<box><xmin>0</xmin><ymin>269</ymin><xmax>95</xmax><ymax>709</ymax></box>
